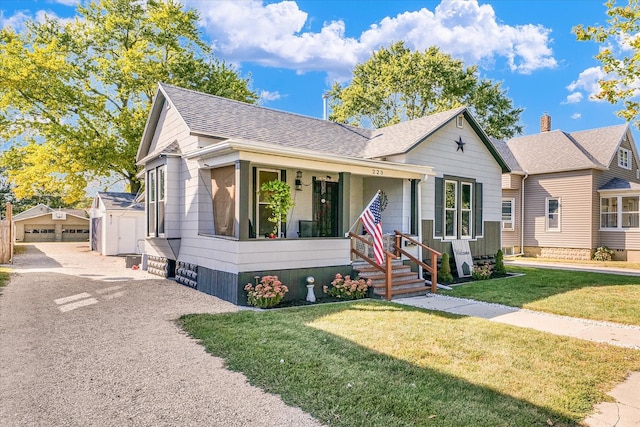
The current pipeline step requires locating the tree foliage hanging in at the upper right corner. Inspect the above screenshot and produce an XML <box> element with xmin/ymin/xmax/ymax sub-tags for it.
<box><xmin>573</xmin><ymin>0</ymin><xmax>640</xmax><ymax>128</ymax></box>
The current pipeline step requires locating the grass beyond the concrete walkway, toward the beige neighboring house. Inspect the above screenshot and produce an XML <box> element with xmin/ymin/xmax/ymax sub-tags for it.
<box><xmin>441</xmin><ymin>266</ymin><xmax>640</xmax><ymax>326</ymax></box>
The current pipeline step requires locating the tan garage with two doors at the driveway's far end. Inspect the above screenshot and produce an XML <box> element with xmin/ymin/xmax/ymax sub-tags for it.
<box><xmin>13</xmin><ymin>203</ymin><xmax>89</xmax><ymax>242</ymax></box>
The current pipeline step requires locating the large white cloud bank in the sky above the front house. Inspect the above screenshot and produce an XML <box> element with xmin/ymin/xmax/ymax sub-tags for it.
<box><xmin>186</xmin><ymin>0</ymin><xmax>557</xmax><ymax>78</ymax></box>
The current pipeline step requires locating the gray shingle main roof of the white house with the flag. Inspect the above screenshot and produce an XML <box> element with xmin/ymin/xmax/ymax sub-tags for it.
<box><xmin>137</xmin><ymin>83</ymin><xmax>507</xmax><ymax>171</ymax></box>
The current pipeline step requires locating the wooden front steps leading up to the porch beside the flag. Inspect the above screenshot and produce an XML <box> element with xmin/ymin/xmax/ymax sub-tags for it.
<box><xmin>353</xmin><ymin>260</ymin><xmax>431</xmax><ymax>298</ymax></box>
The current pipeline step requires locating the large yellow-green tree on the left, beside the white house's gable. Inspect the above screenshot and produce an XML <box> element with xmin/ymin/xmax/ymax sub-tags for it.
<box><xmin>0</xmin><ymin>0</ymin><xmax>257</xmax><ymax>202</ymax></box>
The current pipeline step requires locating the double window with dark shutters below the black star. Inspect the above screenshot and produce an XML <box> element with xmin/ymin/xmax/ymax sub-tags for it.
<box><xmin>434</xmin><ymin>177</ymin><xmax>483</xmax><ymax>239</ymax></box>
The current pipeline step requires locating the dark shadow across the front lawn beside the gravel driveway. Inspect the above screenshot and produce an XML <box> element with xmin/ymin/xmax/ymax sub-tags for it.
<box><xmin>179</xmin><ymin>300</ymin><xmax>600</xmax><ymax>426</ymax></box>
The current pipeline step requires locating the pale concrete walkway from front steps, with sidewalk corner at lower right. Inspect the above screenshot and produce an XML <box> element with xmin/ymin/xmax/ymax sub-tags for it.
<box><xmin>394</xmin><ymin>294</ymin><xmax>640</xmax><ymax>427</ymax></box>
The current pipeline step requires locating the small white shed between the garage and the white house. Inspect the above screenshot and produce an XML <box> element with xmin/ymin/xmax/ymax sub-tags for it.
<box><xmin>90</xmin><ymin>192</ymin><xmax>146</xmax><ymax>255</ymax></box>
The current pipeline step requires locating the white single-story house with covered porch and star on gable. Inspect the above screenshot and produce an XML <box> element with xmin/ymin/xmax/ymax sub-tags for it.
<box><xmin>137</xmin><ymin>84</ymin><xmax>508</xmax><ymax>304</ymax></box>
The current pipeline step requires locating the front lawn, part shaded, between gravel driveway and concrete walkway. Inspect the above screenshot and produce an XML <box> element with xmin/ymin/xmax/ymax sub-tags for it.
<box><xmin>180</xmin><ymin>300</ymin><xmax>640</xmax><ymax>427</ymax></box>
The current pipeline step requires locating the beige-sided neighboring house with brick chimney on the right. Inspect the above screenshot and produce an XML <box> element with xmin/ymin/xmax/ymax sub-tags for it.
<box><xmin>500</xmin><ymin>114</ymin><xmax>640</xmax><ymax>261</ymax></box>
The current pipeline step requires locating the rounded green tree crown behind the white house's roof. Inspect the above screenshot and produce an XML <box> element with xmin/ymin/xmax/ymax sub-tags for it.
<box><xmin>329</xmin><ymin>42</ymin><xmax>523</xmax><ymax>139</ymax></box>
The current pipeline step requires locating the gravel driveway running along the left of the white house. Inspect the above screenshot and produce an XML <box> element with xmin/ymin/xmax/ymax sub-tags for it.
<box><xmin>0</xmin><ymin>243</ymin><xmax>321</xmax><ymax>427</ymax></box>
